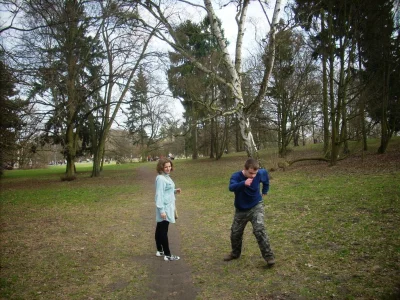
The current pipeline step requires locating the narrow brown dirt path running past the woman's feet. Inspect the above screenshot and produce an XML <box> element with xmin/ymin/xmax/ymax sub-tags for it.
<box><xmin>135</xmin><ymin>167</ymin><xmax>197</xmax><ymax>300</ymax></box>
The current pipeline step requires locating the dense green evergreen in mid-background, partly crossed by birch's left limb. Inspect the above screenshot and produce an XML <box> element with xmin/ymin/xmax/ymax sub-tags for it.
<box><xmin>168</xmin><ymin>18</ymin><xmax>226</xmax><ymax>159</ymax></box>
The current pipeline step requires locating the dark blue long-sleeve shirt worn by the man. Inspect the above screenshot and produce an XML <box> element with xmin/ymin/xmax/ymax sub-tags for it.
<box><xmin>229</xmin><ymin>169</ymin><xmax>269</xmax><ymax>210</ymax></box>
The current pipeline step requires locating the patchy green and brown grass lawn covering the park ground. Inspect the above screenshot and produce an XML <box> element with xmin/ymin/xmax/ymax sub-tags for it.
<box><xmin>0</xmin><ymin>138</ymin><xmax>400</xmax><ymax>299</ymax></box>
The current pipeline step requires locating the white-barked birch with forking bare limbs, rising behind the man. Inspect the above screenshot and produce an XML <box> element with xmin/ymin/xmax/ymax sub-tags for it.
<box><xmin>140</xmin><ymin>0</ymin><xmax>281</xmax><ymax>158</ymax></box>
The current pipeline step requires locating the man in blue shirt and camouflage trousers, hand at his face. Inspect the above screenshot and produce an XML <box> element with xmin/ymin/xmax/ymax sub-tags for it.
<box><xmin>224</xmin><ymin>158</ymin><xmax>275</xmax><ymax>266</ymax></box>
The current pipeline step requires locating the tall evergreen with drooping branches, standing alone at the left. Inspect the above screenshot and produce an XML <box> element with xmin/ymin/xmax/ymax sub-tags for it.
<box><xmin>26</xmin><ymin>0</ymin><xmax>101</xmax><ymax>180</ymax></box>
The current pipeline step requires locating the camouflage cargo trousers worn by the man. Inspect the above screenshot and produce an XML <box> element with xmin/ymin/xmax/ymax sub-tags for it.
<box><xmin>231</xmin><ymin>202</ymin><xmax>274</xmax><ymax>260</ymax></box>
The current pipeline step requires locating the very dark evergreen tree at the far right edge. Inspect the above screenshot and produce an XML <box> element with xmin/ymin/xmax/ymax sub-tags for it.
<box><xmin>360</xmin><ymin>0</ymin><xmax>400</xmax><ymax>153</ymax></box>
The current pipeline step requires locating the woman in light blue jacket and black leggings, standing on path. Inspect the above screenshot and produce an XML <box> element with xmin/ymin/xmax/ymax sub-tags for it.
<box><xmin>155</xmin><ymin>158</ymin><xmax>181</xmax><ymax>261</ymax></box>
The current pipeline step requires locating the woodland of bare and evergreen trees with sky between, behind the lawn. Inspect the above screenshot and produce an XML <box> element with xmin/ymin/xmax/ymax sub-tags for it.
<box><xmin>0</xmin><ymin>0</ymin><xmax>400</xmax><ymax>180</ymax></box>
